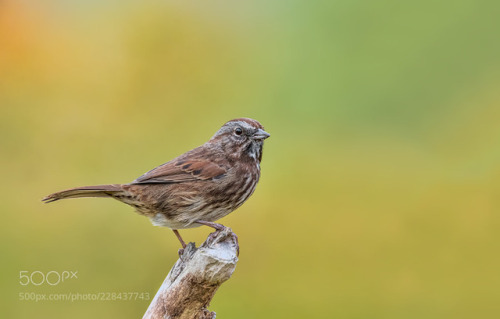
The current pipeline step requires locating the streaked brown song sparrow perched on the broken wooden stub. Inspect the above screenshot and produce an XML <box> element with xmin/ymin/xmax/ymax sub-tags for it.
<box><xmin>43</xmin><ymin>118</ymin><xmax>269</xmax><ymax>248</ymax></box>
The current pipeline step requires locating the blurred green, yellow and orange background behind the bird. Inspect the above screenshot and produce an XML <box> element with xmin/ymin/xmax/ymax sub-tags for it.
<box><xmin>0</xmin><ymin>0</ymin><xmax>500</xmax><ymax>318</ymax></box>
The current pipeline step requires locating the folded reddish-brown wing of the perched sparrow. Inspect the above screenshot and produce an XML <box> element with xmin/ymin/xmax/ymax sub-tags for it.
<box><xmin>131</xmin><ymin>154</ymin><xmax>227</xmax><ymax>184</ymax></box>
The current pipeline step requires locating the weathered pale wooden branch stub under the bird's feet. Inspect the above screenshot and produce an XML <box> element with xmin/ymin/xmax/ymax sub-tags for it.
<box><xmin>143</xmin><ymin>228</ymin><xmax>238</xmax><ymax>319</ymax></box>
